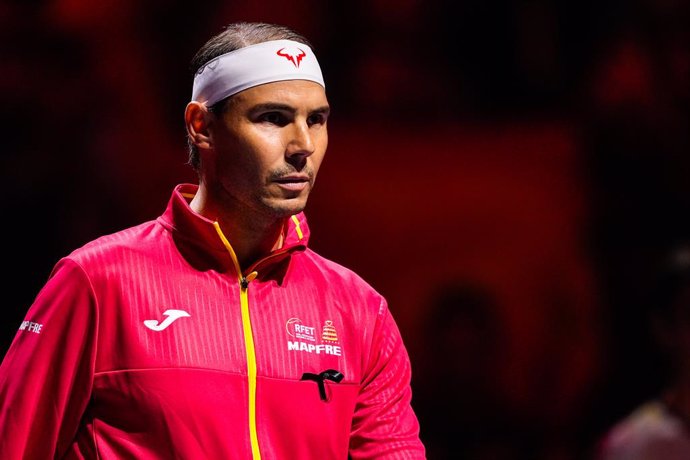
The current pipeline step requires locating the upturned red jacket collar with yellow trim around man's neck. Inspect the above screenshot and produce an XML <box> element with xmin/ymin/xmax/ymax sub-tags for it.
<box><xmin>158</xmin><ymin>184</ymin><xmax>310</xmax><ymax>277</ymax></box>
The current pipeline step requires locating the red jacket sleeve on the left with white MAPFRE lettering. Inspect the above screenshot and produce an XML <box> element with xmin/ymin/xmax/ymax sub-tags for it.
<box><xmin>0</xmin><ymin>259</ymin><xmax>97</xmax><ymax>459</ymax></box>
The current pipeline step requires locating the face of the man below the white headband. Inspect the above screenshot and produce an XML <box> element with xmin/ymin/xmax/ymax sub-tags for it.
<box><xmin>206</xmin><ymin>80</ymin><xmax>329</xmax><ymax>218</ymax></box>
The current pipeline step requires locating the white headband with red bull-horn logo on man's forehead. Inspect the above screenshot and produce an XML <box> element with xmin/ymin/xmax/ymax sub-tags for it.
<box><xmin>192</xmin><ymin>40</ymin><xmax>326</xmax><ymax>106</ymax></box>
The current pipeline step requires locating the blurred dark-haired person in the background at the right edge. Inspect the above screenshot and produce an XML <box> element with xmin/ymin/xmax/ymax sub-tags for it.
<box><xmin>593</xmin><ymin>244</ymin><xmax>690</xmax><ymax>460</ymax></box>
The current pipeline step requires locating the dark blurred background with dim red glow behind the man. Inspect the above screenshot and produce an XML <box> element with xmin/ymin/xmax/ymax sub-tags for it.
<box><xmin>0</xmin><ymin>0</ymin><xmax>690</xmax><ymax>460</ymax></box>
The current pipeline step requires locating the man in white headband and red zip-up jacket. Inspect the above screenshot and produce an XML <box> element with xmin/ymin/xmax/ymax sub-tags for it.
<box><xmin>0</xmin><ymin>23</ymin><xmax>425</xmax><ymax>459</ymax></box>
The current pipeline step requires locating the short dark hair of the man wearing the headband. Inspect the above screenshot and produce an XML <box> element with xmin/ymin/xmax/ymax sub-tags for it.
<box><xmin>187</xmin><ymin>22</ymin><xmax>313</xmax><ymax>172</ymax></box>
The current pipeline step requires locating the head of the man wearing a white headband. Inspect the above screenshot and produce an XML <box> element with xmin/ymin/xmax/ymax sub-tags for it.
<box><xmin>185</xmin><ymin>23</ymin><xmax>329</xmax><ymax>218</ymax></box>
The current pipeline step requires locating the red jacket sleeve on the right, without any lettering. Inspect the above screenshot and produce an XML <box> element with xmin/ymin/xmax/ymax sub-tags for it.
<box><xmin>350</xmin><ymin>300</ymin><xmax>426</xmax><ymax>460</ymax></box>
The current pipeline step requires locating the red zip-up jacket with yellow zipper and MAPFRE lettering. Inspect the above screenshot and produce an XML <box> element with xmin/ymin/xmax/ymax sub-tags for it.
<box><xmin>0</xmin><ymin>185</ymin><xmax>424</xmax><ymax>460</ymax></box>
